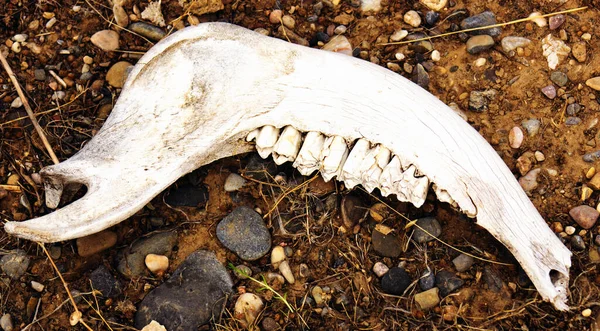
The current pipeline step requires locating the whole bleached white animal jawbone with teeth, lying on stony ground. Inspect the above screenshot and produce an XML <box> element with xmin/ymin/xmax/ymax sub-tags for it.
<box><xmin>5</xmin><ymin>23</ymin><xmax>571</xmax><ymax>310</ymax></box>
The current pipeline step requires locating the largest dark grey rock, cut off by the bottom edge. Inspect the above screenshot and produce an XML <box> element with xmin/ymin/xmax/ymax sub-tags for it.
<box><xmin>135</xmin><ymin>250</ymin><xmax>233</xmax><ymax>331</ymax></box>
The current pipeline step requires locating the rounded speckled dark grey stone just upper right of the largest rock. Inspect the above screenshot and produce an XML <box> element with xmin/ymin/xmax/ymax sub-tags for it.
<box><xmin>217</xmin><ymin>206</ymin><xmax>271</xmax><ymax>261</ymax></box>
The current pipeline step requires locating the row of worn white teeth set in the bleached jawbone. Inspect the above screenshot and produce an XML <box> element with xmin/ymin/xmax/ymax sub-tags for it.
<box><xmin>246</xmin><ymin>125</ymin><xmax>456</xmax><ymax>207</ymax></box>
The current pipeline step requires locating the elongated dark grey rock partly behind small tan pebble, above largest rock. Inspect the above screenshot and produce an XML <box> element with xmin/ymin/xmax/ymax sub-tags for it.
<box><xmin>117</xmin><ymin>232</ymin><xmax>177</xmax><ymax>278</ymax></box>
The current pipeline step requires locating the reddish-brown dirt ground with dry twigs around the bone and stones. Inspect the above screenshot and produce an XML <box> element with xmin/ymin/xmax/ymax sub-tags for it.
<box><xmin>0</xmin><ymin>0</ymin><xmax>600</xmax><ymax>330</ymax></box>
